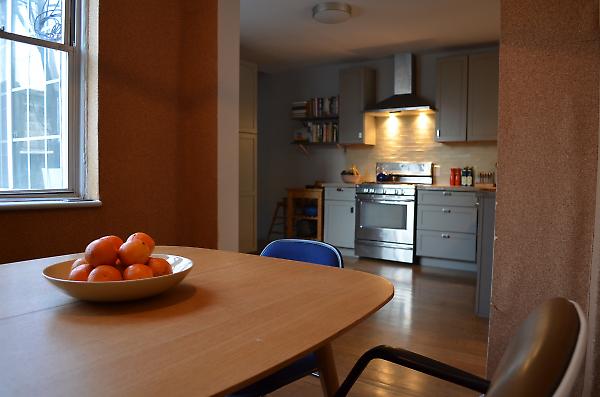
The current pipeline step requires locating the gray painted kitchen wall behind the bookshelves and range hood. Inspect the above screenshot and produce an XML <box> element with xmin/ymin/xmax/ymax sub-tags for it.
<box><xmin>258</xmin><ymin>47</ymin><xmax>496</xmax><ymax>241</ymax></box>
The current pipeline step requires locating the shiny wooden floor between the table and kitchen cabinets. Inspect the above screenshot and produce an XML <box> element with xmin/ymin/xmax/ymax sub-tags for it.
<box><xmin>270</xmin><ymin>258</ymin><xmax>488</xmax><ymax>397</ymax></box>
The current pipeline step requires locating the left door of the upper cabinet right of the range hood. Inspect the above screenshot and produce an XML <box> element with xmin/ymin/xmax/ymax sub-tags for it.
<box><xmin>435</xmin><ymin>56</ymin><xmax>468</xmax><ymax>142</ymax></box>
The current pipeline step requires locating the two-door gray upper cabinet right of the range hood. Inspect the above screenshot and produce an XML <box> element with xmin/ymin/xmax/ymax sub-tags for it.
<box><xmin>436</xmin><ymin>51</ymin><xmax>498</xmax><ymax>142</ymax></box>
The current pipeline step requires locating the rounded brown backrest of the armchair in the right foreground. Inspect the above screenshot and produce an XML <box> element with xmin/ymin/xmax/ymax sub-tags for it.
<box><xmin>486</xmin><ymin>298</ymin><xmax>587</xmax><ymax>397</ymax></box>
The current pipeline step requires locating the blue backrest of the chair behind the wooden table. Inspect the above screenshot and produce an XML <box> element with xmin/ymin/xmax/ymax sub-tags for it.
<box><xmin>260</xmin><ymin>239</ymin><xmax>344</xmax><ymax>268</ymax></box>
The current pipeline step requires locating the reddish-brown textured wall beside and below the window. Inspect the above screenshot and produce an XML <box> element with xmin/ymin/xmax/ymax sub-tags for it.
<box><xmin>0</xmin><ymin>0</ymin><xmax>217</xmax><ymax>263</ymax></box>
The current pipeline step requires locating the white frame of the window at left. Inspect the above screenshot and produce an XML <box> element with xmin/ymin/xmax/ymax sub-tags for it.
<box><xmin>0</xmin><ymin>0</ymin><xmax>88</xmax><ymax>201</ymax></box>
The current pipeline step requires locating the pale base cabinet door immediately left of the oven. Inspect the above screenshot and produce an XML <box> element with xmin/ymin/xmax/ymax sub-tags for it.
<box><xmin>325</xmin><ymin>200</ymin><xmax>355</xmax><ymax>248</ymax></box>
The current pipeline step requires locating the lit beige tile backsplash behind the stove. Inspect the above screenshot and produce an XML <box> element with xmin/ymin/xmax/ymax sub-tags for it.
<box><xmin>346</xmin><ymin>114</ymin><xmax>497</xmax><ymax>185</ymax></box>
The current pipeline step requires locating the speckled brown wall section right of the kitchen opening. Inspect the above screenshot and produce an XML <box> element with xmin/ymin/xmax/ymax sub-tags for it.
<box><xmin>488</xmin><ymin>0</ymin><xmax>600</xmax><ymax>373</ymax></box>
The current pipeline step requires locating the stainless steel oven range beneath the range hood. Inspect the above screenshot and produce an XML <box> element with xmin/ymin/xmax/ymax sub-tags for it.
<box><xmin>354</xmin><ymin>163</ymin><xmax>433</xmax><ymax>263</ymax></box>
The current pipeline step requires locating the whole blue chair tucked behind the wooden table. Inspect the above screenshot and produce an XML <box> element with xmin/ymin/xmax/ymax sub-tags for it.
<box><xmin>230</xmin><ymin>239</ymin><xmax>344</xmax><ymax>397</ymax></box>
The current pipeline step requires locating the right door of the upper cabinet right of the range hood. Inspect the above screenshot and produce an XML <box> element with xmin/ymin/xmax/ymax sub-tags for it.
<box><xmin>467</xmin><ymin>52</ymin><xmax>498</xmax><ymax>141</ymax></box>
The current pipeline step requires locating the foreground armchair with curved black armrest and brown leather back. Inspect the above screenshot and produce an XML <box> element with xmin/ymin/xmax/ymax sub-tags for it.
<box><xmin>335</xmin><ymin>298</ymin><xmax>587</xmax><ymax>397</ymax></box>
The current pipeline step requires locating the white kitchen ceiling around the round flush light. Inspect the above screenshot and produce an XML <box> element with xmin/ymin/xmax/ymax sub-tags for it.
<box><xmin>240</xmin><ymin>0</ymin><xmax>500</xmax><ymax>71</ymax></box>
